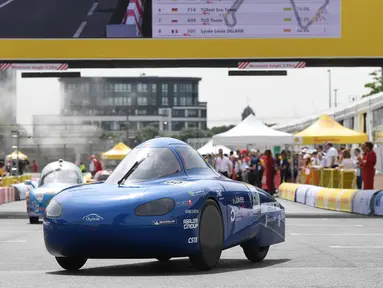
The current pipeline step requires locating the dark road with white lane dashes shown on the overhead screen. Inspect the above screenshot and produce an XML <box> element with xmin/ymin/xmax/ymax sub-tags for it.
<box><xmin>0</xmin><ymin>0</ymin><xmax>118</xmax><ymax>38</ymax></box>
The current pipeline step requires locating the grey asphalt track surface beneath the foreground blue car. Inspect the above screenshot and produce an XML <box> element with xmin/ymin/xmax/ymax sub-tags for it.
<box><xmin>0</xmin><ymin>201</ymin><xmax>383</xmax><ymax>288</ymax></box>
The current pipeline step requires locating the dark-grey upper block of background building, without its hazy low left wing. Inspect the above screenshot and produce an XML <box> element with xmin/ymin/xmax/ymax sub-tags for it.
<box><xmin>60</xmin><ymin>76</ymin><xmax>207</xmax><ymax>137</ymax></box>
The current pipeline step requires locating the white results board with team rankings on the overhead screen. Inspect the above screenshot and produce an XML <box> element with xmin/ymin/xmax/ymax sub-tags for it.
<box><xmin>152</xmin><ymin>0</ymin><xmax>341</xmax><ymax>38</ymax></box>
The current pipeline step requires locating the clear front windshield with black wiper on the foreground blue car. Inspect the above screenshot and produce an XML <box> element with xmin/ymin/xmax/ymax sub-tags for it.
<box><xmin>105</xmin><ymin>147</ymin><xmax>181</xmax><ymax>184</ymax></box>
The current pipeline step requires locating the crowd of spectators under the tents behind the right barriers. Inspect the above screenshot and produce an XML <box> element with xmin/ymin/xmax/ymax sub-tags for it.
<box><xmin>203</xmin><ymin>142</ymin><xmax>376</xmax><ymax>194</ymax></box>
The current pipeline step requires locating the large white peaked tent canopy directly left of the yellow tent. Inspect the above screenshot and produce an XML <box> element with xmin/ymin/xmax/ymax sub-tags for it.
<box><xmin>213</xmin><ymin>115</ymin><xmax>294</xmax><ymax>148</ymax></box>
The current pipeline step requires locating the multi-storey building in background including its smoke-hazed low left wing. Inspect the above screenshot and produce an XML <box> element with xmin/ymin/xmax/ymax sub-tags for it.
<box><xmin>28</xmin><ymin>76</ymin><xmax>207</xmax><ymax>165</ymax></box>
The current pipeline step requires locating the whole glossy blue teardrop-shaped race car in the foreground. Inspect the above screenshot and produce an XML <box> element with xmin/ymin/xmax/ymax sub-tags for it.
<box><xmin>43</xmin><ymin>138</ymin><xmax>285</xmax><ymax>271</ymax></box>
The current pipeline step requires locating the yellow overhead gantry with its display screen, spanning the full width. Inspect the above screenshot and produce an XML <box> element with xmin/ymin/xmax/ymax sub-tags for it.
<box><xmin>0</xmin><ymin>0</ymin><xmax>383</xmax><ymax>60</ymax></box>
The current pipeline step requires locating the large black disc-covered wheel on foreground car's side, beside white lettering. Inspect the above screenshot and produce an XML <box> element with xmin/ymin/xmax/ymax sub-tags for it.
<box><xmin>189</xmin><ymin>199</ymin><xmax>223</xmax><ymax>271</ymax></box>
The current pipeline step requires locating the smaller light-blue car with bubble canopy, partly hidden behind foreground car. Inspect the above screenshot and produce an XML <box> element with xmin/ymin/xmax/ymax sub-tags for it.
<box><xmin>25</xmin><ymin>159</ymin><xmax>83</xmax><ymax>224</ymax></box>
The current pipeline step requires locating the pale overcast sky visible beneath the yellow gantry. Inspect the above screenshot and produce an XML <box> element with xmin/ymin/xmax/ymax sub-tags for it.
<box><xmin>17</xmin><ymin>68</ymin><xmax>376</xmax><ymax>127</ymax></box>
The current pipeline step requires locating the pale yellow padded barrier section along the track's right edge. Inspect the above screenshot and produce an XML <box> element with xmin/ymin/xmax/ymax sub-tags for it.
<box><xmin>315</xmin><ymin>188</ymin><xmax>357</xmax><ymax>212</ymax></box>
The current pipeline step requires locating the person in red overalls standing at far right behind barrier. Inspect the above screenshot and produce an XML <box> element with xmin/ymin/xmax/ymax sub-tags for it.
<box><xmin>362</xmin><ymin>142</ymin><xmax>376</xmax><ymax>190</ymax></box>
